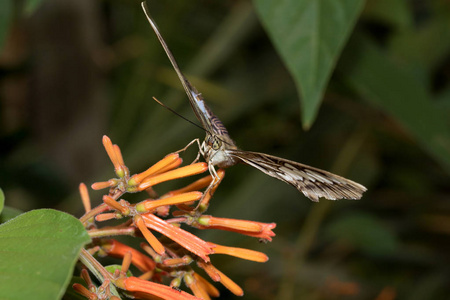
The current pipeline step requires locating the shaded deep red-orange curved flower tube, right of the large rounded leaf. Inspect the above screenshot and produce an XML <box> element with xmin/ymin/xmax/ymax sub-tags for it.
<box><xmin>101</xmin><ymin>240</ymin><xmax>156</xmax><ymax>272</ymax></box>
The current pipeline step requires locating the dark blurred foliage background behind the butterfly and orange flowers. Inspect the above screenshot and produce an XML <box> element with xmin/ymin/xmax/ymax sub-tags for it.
<box><xmin>0</xmin><ymin>0</ymin><xmax>450</xmax><ymax>300</ymax></box>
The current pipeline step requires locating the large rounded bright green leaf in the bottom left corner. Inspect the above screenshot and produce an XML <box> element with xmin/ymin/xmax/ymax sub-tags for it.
<box><xmin>0</xmin><ymin>209</ymin><xmax>90</xmax><ymax>300</ymax></box>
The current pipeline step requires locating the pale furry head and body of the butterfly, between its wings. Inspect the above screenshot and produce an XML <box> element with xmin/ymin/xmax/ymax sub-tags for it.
<box><xmin>201</xmin><ymin>134</ymin><xmax>239</xmax><ymax>168</ymax></box>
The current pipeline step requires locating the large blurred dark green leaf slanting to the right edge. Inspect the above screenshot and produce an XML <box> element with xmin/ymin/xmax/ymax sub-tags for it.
<box><xmin>338</xmin><ymin>35</ymin><xmax>450</xmax><ymax>171</ymax></box>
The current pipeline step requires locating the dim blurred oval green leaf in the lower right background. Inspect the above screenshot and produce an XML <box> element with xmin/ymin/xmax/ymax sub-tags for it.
<box><xmin>325</xmin><ymin>213</ymin><xmax>399</xmax><ymax>255</ymax></box>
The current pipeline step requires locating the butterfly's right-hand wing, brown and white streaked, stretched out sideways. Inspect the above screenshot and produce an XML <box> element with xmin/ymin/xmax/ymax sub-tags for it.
<box><xmin>227</xmin><ymin>150</ymin><xmax>367</xmax><ymax>202</ymax></box>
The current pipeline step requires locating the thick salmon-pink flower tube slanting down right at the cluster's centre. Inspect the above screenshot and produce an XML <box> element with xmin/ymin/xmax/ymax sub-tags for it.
<box><xmin>142</xmin><ymin>213</ymin><xmax>213</xmax><ymax>261</ymax></box>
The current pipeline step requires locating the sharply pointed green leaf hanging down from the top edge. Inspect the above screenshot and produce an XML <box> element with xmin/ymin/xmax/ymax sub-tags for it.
<box><xmin>253</xmin><ymin>0</ymin><xmax>364</xmax><ymax>128</ymax></box>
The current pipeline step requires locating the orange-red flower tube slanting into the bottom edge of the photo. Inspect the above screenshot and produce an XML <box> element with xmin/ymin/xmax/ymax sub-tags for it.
<box><xmin>116</xmin><ymin>276</ymin><xmax>199</xmax><ymax>300</ymax></box>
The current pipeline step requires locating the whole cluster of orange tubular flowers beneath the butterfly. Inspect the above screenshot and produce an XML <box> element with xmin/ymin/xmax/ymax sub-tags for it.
<box><xmin>73</xmin><ymin>136</ymin><xmax>276</xmax><ymax>299</ymax></box>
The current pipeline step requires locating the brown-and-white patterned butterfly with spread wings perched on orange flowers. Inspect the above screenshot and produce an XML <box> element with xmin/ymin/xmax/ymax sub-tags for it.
<box><xmin>141</xmin><ymin>2</ymin><xmax>367</xmax><ymax>202</ymax></box>
